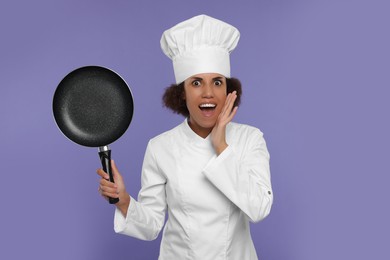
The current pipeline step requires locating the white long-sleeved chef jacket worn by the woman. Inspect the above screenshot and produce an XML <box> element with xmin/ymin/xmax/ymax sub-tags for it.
<box><xmin>114</xmin><ymin>120</ymin><xmax>273</xmax><ymax>260</ymax></box>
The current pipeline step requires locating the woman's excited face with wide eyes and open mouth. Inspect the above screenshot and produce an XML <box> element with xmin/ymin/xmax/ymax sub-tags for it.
<box><xmin>184</xmin><ymin>73</ymin><xmax>227</xmax><ymax>138</ymax></box>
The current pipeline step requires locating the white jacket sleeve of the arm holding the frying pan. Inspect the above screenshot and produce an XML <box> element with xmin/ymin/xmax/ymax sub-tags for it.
<box><xmin>114</xmin><ymin>142</ymin><xmax>166</xmax><ymax>240</ymax></box>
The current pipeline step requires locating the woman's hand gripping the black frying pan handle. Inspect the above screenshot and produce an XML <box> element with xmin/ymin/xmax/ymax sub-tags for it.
<box><xmin>97</xmin><ymin>160</ymin><xmax>130</xmax><ymax>217</ymax></box>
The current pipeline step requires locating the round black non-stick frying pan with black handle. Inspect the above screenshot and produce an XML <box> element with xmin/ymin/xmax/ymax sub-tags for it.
<box><xmin>53</xmin><ymin>66</ymin><xmax>134</xmax><ymax>204</ymax></box>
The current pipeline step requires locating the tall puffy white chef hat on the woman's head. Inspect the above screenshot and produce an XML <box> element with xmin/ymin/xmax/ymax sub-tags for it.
<box><xmin>160</xmin><ymin>15</ymin><xmax>240</xmax><ymax>84</ymax></box>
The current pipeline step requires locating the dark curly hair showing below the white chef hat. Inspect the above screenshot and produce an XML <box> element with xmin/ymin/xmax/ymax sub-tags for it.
<box><xmin>163</xmin><ymin>78</ymin><xmax>242</xmax><ymax>117</ymax></box>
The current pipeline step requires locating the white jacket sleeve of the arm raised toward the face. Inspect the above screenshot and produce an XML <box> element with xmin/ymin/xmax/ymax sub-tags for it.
<box><xmin>203</xmin><ymin>127</ymin><xmax>273</xmax><ymax>222</ymax></box>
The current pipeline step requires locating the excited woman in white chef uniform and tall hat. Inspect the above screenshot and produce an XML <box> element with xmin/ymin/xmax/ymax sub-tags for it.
<box><xmin>98</xmin><ymin>15</ymin><xmax>273</xmax><ymax>260</ymax></box>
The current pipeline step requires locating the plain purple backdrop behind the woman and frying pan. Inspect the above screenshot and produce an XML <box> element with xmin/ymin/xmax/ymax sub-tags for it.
<box><xmin>0</xmin><ymin>0</ymin><xmax>390</xmax><ymax>260</ymax></box>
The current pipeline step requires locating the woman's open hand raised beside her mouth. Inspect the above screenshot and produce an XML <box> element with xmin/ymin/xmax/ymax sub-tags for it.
<box><xmin>211</xmin><ymin>91</ymin><xmax>238</xmax><ymax>155</ymax></box>
